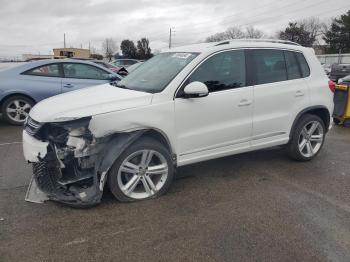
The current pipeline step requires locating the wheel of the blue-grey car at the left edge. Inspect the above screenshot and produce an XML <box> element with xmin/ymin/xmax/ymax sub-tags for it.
<box><xmin>1</xmin><ymin>96</ymin><xmax>34</xmax><ymax>125</ymax></box>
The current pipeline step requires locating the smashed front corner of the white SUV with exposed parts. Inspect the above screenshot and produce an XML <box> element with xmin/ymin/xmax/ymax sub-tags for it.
<box><xmin>23</xmin><ymin>116</ymin><xmax>145</xmax><ymax>206</ymax></box>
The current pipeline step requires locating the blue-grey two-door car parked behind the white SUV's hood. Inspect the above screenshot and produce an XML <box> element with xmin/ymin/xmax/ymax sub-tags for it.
<box><xmin>0</xmin><ymin>59</ymin><xmax>122</xmax><ymax>125</ymax></box>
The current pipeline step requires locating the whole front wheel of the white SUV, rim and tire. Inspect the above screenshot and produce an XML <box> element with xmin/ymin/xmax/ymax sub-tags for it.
<box><xmin>108</xmin><ymin>138</ymin><xmax>174</xmax><ymax>202</ymax></box>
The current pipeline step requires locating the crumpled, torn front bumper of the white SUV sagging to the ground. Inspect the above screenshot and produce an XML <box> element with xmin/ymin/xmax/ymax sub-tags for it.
<box><xmin>23</xmin><ymin>131</ymin><xmax>102</xmax><ymax>206</ymax></box>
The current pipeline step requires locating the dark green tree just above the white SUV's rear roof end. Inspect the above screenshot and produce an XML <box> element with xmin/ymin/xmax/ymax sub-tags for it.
<box><xmin>279</xmin><ymin>22</ymin><xmax>316</xmax><ymax>47</ymax></box>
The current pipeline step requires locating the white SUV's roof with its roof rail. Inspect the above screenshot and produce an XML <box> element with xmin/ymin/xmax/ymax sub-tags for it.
<box><xmin>163</xmin><ymin>39</ymin><xmax>305</xmax><ymax>53</ymax></box>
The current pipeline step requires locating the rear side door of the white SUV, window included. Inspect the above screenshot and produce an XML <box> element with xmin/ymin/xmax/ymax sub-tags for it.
<box><xmin>249</xmin><ymin>49</ymin><xmax>309</xmax><ymax>146</ymax></box>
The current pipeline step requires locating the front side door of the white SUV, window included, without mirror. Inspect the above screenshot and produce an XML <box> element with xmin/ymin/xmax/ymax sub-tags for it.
<box><xmin>175</xmin><ymin>50</ymin><xmax>253</xmax><ymax>158</ymax></box>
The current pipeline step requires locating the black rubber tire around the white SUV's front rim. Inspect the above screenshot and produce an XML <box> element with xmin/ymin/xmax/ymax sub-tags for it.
<box><xmin>108</xmin><ymin>137</ymin><xmax>174</xmax><ymax>202</ymax></box>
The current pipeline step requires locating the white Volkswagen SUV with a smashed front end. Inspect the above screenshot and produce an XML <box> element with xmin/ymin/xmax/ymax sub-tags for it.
<box><xmin>23</xmin><ymin>40</ymin><xmax>333</xmax><ymax>206</ymax></box>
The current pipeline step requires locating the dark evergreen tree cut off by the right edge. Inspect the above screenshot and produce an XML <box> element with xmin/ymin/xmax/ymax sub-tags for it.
<box><xmin>323</xmin><ymin>10</ymin><xmax>350</xmax><ymax>53</ymax></box>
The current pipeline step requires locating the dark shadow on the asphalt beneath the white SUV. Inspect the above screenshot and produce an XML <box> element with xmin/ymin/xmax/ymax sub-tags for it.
<box><xmin>101</xmin><ymin>147</ymin><xmax>288</xmax><ymax>206</ymax></box>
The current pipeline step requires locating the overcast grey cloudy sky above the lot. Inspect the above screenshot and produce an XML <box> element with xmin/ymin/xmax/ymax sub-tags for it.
<box><xmin>0</xmin><ymin>0</ymin><xmax>350</xmax><ymax>57</ymax></box>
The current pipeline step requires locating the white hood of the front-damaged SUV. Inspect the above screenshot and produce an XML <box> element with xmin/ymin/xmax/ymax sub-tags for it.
<box><xmin>30</xmin><ymin>84</ymin><xmax>153</xmax><ymax>123</ymax></box>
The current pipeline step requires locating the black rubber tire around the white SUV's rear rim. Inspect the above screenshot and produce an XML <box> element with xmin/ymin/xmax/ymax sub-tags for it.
<box><xmin>286</xmin><ymin>114</ymin><xmax>326</xmax><ymax>161</ymax></box>
